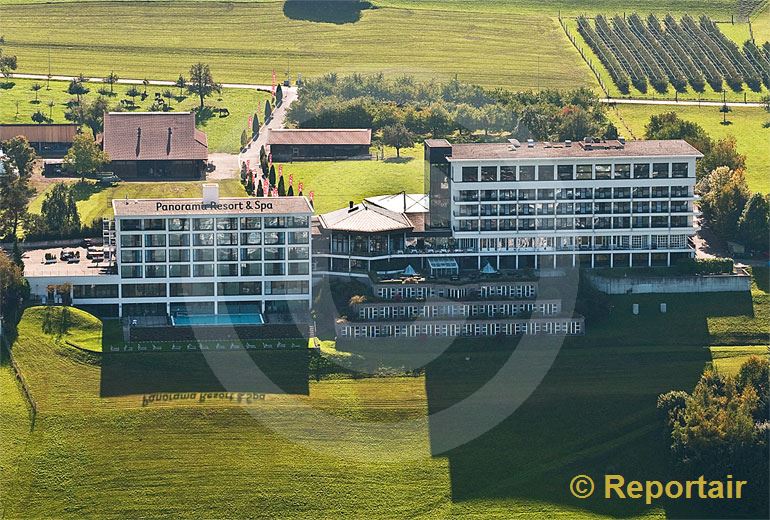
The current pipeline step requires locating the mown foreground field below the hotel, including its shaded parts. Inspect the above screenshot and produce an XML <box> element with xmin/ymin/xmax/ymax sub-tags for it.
<box><xmin>0</xmin><ymin>273</ymin><xmax>768</xmax><ymax>518</ymax></box>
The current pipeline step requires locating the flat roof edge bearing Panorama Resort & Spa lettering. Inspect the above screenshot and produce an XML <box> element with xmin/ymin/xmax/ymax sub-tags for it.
<box><xmin>112</xmin><ymin>197</ymin><xmax>313</xmax><ymax>218</ymax></box>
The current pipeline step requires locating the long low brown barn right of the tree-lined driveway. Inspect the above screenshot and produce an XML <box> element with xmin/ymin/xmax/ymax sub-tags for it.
<box><xmin>267</xmin><ymin>128</ymin><xmax>372</xmax><ymax>162</ymax></box>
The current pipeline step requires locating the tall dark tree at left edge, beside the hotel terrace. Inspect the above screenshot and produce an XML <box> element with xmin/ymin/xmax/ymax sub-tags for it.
<box><xmin>0</xmin><ymin>136</ymin><xmax>37</xmax><ymax>241</ymax></box>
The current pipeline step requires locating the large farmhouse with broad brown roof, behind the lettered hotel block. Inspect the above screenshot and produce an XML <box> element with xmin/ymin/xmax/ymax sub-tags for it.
<box><xmin>101</xmin><ymin>112</ymin><xmax>209</xmax><ymax>180</ymax></box>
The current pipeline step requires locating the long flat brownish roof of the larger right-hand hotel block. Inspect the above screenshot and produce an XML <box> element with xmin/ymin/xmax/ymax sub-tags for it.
<box><xmin>447</xmin><ymin>139</ymin><xmax>703</xmax><ymax>161</ymax></box>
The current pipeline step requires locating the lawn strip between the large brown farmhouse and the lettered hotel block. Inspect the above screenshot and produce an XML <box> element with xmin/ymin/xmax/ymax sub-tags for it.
<box><xmin>29</xmin><ymin>179</ymin><xmax>246</xmax><ymax>223</ymax></box>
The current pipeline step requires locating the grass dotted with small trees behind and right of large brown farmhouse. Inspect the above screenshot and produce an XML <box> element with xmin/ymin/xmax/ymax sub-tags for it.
<box><xmin>0</xmin><ymin>77</ymin><xmax>270</xmax><ymax>153</ymax></box>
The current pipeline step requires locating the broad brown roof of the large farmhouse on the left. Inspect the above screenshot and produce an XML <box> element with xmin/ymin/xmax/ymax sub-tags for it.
<box><xmin>102</xmin><ymin>112</ymin><xmax>208</xmax><ymax>161</ymax></box>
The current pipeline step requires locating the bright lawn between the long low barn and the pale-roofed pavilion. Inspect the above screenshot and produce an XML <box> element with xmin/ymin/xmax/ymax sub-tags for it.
<box><xmin>276</xmin><ymin>146</ymin><xmax>425</xmax><ymax>213</ymax></box>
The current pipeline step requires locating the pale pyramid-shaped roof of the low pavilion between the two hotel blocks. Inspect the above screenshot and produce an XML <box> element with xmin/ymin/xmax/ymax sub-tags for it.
<box><xmin>318</xmin><ymin>202</ymin><xmax>413</xmax><ymax>233</ymax></box>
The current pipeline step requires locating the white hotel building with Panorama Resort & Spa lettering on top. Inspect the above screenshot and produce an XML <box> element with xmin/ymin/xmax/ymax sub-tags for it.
<box><xmin>26</xmin><ymin>184</ymin><xmax>313</xmax><ymax>317</ymax></box>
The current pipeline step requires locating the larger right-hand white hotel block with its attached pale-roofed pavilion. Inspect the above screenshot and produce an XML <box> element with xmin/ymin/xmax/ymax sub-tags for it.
<box><xmin>314</xmin><ymin>139</ymin><xmax>702</xmax><ymax>275</ymax></box>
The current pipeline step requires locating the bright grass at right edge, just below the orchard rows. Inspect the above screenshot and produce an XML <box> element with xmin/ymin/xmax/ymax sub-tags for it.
<box><xmin>609</xmin><ymin>105</ymin><xmax>770</xmax><ymax>193</ymax></box>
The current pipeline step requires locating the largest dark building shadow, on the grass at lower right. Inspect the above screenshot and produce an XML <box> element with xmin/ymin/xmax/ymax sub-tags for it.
<box><xmin>416</xmin><ymin>288</ymin><xmax>751</xmax><ymax>517</ymax></box>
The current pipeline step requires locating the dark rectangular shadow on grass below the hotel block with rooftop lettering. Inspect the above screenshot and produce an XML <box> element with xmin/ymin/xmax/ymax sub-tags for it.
<box><xmin>100</xmin><ymin>349</ymin><xmax>310</xmax><ymax>397</ymax></box>
